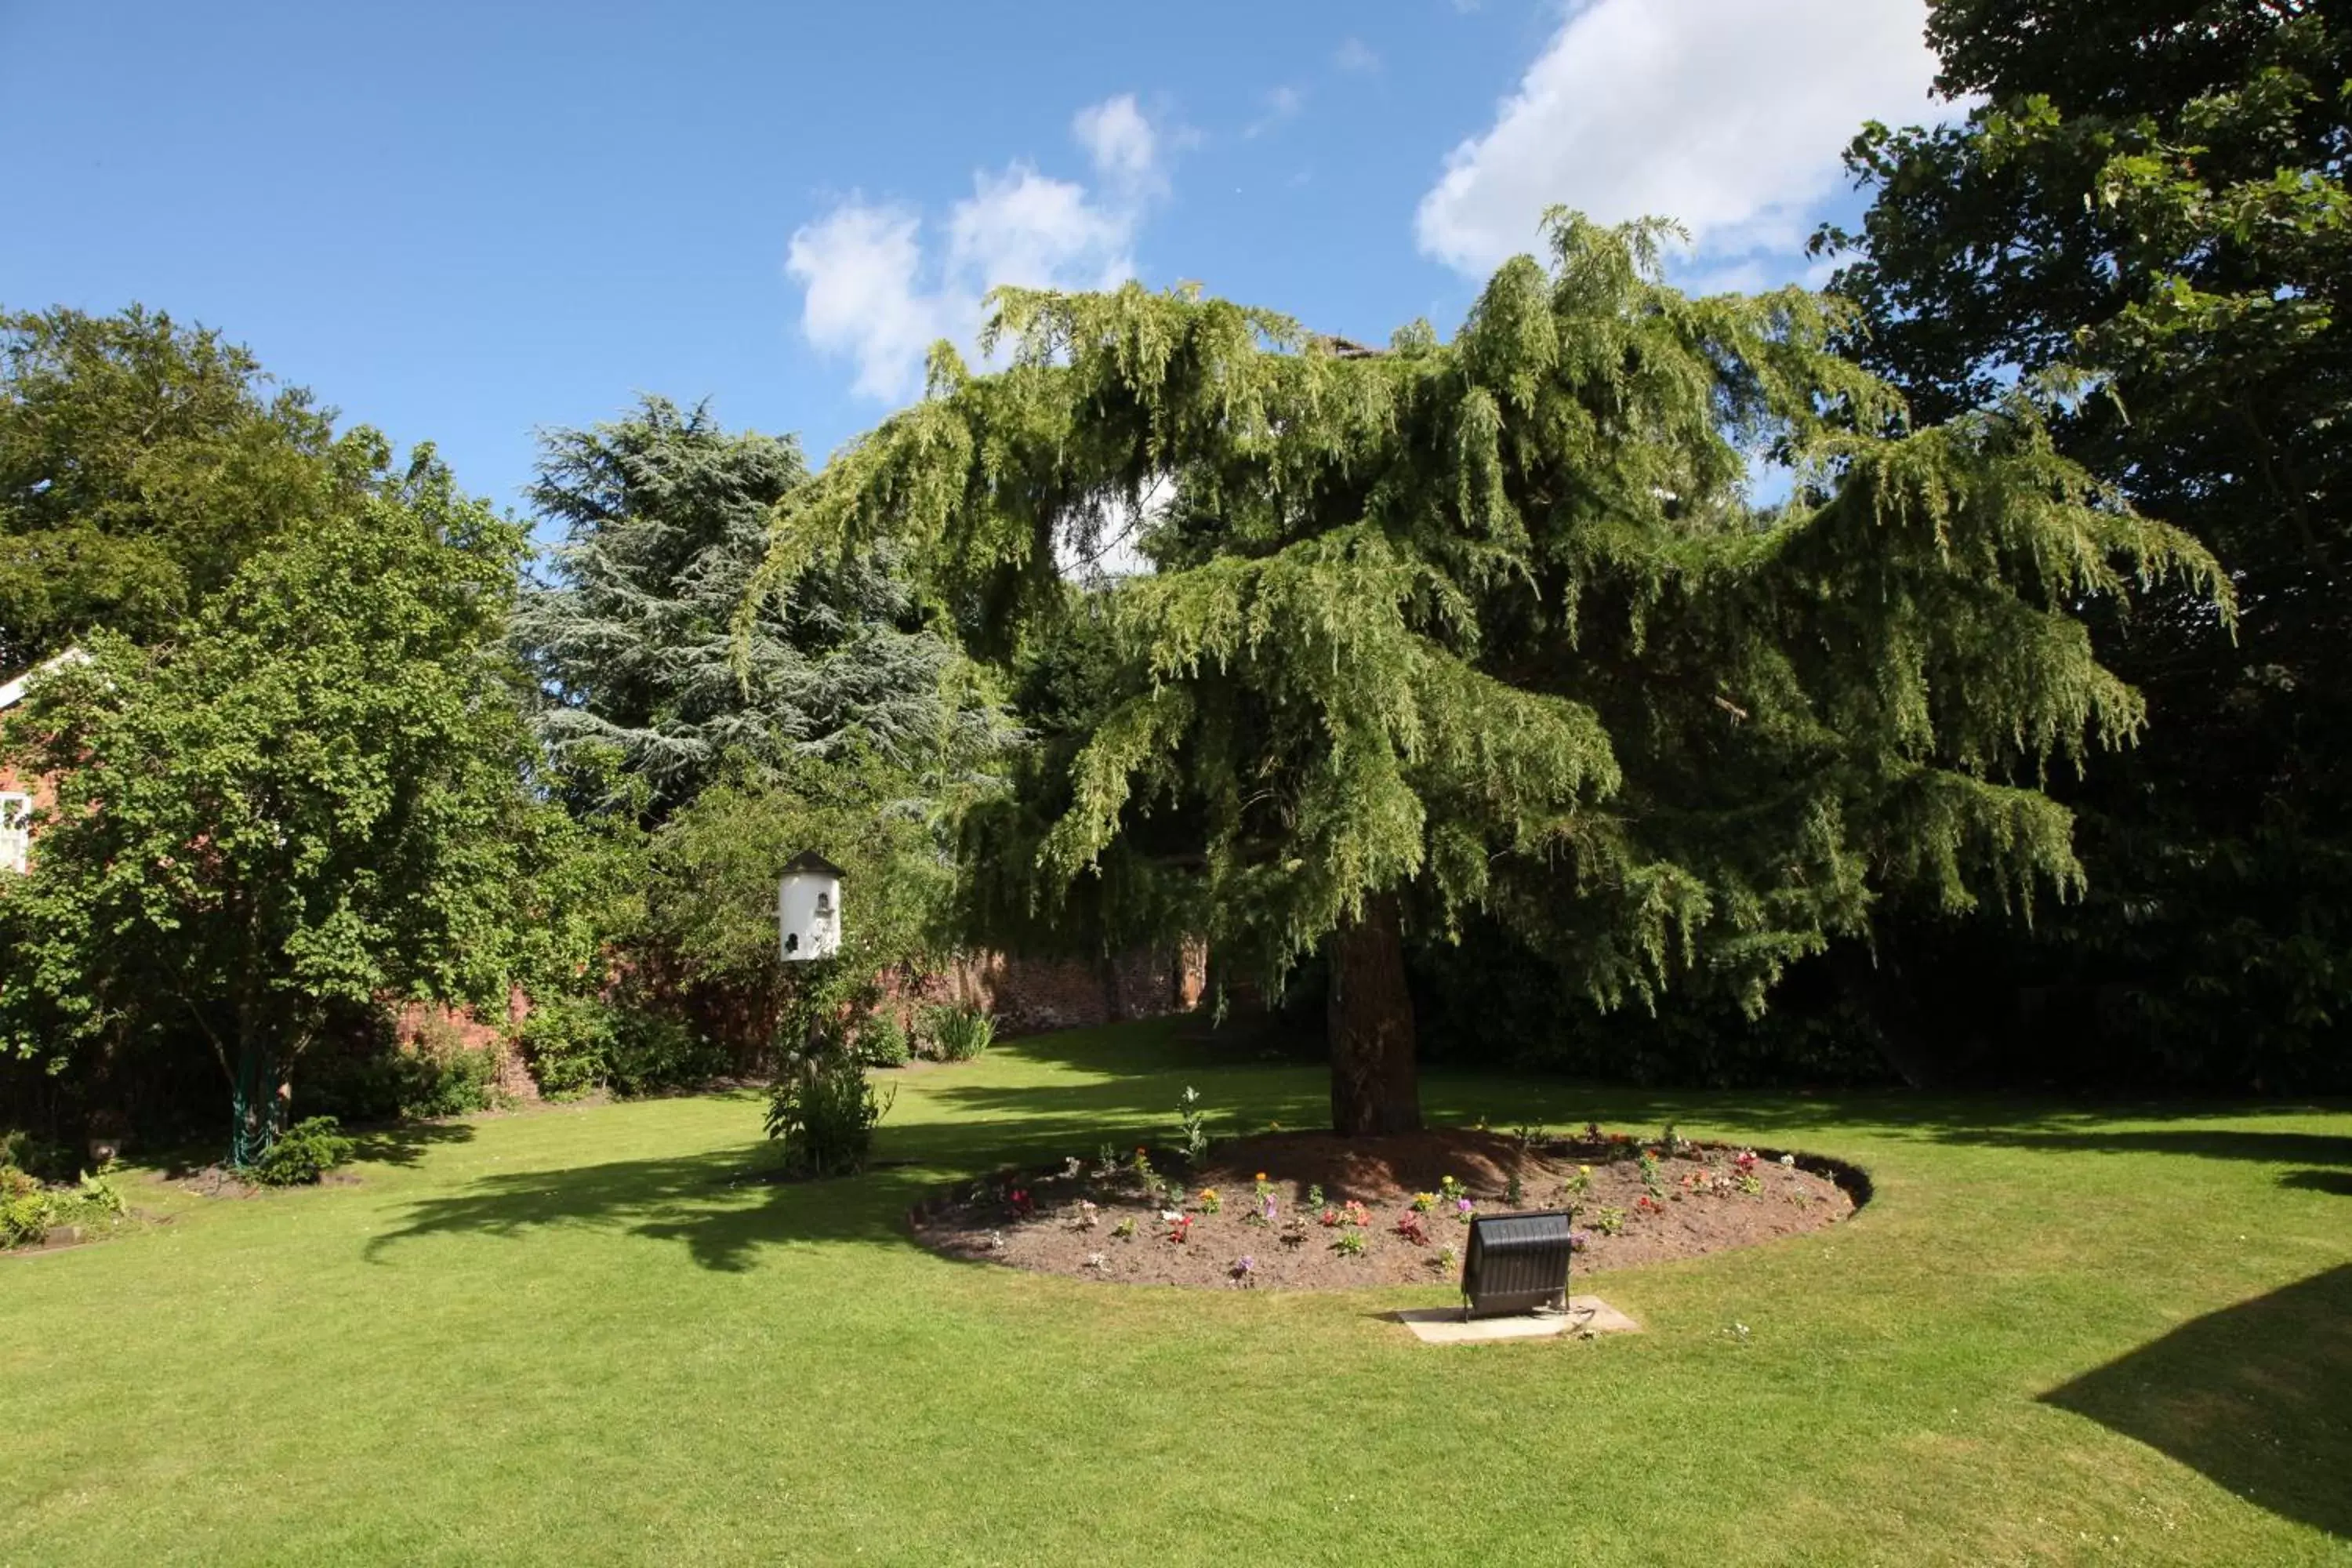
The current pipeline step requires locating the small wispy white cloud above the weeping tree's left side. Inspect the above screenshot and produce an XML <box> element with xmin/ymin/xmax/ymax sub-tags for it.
<box><xmin>783</xmin><ymin>94</ymin><xmax>1167</xmax><ymax>402</ymax></box>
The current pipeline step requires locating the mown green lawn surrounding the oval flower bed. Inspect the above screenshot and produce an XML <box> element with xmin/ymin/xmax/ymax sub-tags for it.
<box><xmin>0</xmin><ymin>1025</ymin><xmax>2352</xmax><ymax>1568</ymax></box>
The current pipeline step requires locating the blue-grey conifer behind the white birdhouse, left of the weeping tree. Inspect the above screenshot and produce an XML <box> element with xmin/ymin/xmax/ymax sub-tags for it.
<box><xmin>515</xmin><ymin>397</ymin><xmax>995</xmax><ymax>815</ymax></box>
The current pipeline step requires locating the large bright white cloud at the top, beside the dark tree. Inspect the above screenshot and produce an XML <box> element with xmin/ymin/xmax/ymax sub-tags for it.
<box><xmin>1416</xmin><ymin>0</ymin><xmax>1945</xmax><ymax>275</ymax></box>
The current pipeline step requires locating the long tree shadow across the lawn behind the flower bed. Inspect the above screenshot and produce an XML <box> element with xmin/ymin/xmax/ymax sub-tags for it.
<box><xmin>365</xmin><ymin>1020</ymin><xmax>2352</xmax><ymax>1272</ymax></box>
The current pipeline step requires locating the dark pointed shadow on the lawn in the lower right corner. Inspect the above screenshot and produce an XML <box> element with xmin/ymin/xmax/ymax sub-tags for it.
<box><xmin>2042</xmin><ymin>1265</ymin><xmax>2352</xmax><ymax>1537</ymax></box>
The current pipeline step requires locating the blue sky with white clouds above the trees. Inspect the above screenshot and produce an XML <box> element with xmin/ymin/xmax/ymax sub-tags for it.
<box><xmin>0</xmin><ymin>0</ymin><xmax>1950</xmax><ymax>531</ymax></box>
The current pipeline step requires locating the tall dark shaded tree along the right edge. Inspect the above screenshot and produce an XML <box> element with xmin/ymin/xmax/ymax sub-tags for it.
<box><xmin>1816</xmin><ymin>0</ymin><xmax>2352</xmax><ymax>1083</ymax></box>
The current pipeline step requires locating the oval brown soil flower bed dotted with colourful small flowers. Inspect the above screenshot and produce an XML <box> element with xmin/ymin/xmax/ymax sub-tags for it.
<box><xmin>910</xmin><ymin>1128</ymin><xmax>1867</xmax><ymax>1290</ymax></box>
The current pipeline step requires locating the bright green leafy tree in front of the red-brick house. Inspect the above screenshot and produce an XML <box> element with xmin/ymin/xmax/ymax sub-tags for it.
<box><xmin>0</xmin><ymin>435</ymin><xmax>560</xmax><ymax>1163</ymax></box>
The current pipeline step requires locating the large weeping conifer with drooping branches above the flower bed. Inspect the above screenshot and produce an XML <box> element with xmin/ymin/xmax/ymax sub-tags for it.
<box><xmin>767</xmin><ymin>214</ymin><xmax>2211</xmax><ymax>1133</ymax></box>
